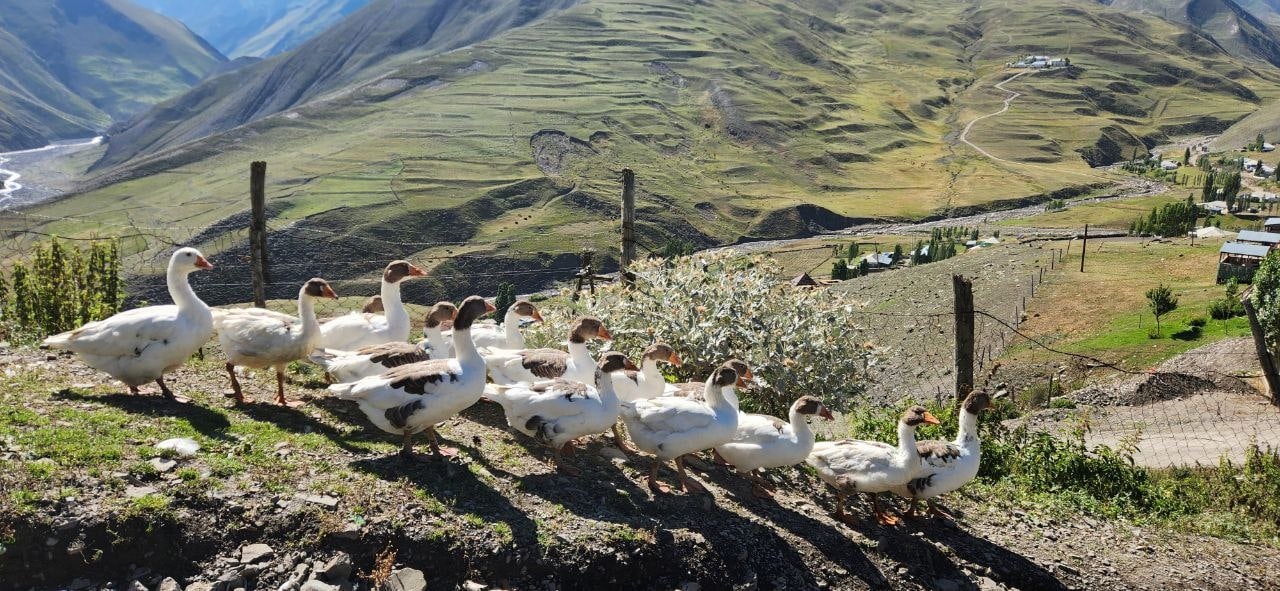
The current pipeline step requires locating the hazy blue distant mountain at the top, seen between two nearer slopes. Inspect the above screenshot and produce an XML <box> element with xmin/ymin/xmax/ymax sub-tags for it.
<box><xmin>137</xmin><ymin>0</ymin><xmax>369</xmax><ymax>58</ymax></box>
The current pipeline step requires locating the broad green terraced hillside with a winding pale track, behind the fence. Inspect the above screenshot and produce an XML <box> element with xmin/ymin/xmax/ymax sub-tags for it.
<box><xmin>15</xmin><ymin>0</ymin><xmax>1280</xmax><ymax>297</ymax></box>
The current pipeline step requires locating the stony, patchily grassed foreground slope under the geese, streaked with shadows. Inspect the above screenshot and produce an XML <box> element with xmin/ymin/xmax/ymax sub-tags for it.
<box><xmin>0</xmin><ymin>342</ymin><xmax>1280</xmax><ymax>591</ymax></box>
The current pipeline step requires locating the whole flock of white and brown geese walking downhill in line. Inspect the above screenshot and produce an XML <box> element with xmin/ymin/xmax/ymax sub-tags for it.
<box><xmin>45</xmin><ymin>248</ymin><xmax>989</xmax><ymax>524</ymax></box>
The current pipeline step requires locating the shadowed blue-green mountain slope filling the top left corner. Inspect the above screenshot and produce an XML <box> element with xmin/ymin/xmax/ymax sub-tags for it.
<box><xmin>0</xmin><ymin>0</ymin><xmax>224</xmax><ymax>148</ymax></box>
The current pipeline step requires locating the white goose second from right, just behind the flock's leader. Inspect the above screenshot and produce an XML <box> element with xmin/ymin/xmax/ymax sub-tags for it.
<box><xmin>805</xmin><ymin>407</ymin><xmax>938</xmax><ymax>526</ymax></box>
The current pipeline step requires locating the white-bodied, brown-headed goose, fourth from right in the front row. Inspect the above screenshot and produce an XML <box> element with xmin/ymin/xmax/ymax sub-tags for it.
<box><xmin>621</xmin><ymin>366</ymin><xmax>739</xmax><ymax>493</ymax></box>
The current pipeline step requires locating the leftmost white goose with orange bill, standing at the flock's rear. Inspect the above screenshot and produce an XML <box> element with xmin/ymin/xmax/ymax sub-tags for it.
<box><xmin>45</xmin><ymin>248</ymin><xmax>214</xmax><ymax>402</ymax></box>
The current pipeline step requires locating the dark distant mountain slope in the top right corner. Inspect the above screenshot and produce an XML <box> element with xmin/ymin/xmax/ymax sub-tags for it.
<box><xmin>1101</xmin><ymin>0</ymin><xmax>1280</xmax><ymax>65</ymax></box>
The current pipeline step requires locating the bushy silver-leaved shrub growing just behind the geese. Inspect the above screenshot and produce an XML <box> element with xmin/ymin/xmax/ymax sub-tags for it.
<box><xmin>529</xmin><ymin>253</ymin><xmax>876</xmax><ymax>417</ymax></box>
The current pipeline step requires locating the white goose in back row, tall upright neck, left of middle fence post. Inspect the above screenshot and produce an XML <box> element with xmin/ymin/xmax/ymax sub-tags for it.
<box><xmin>319</xmin><ymin>261</ymin><xmax>426</xmax><ymax>351</ymax></box>
